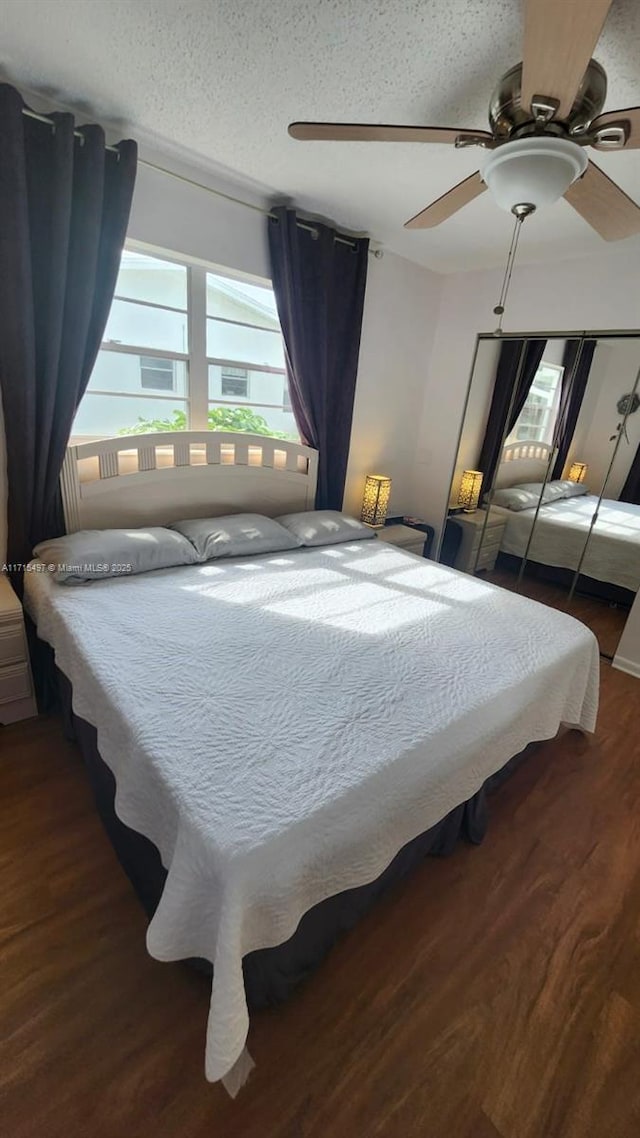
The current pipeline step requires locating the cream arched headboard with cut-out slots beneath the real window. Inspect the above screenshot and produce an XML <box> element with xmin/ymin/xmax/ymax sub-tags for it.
<box><xmin>60</xmin><ymin>431</ymin><xmax>318</xmax><ymax>534</ymax></box>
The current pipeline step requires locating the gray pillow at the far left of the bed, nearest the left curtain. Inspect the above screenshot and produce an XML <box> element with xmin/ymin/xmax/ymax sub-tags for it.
<box><xmin>33</xmin><ymin>526</ymin><xmax>198</xmax><ymax>585</ymax></box>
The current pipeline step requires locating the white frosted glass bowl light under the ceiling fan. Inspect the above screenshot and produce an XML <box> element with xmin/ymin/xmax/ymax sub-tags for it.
<box><xmin>482</xmin><ymin>135</ymin><xmax>588</xmax><ymax>213</ymax></box>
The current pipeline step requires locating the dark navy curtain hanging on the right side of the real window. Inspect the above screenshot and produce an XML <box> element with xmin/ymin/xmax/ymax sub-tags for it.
<box><xmin>268</xmin><ymin>206</ymin><xmax>369</xmax><ymax>510</ymax></box>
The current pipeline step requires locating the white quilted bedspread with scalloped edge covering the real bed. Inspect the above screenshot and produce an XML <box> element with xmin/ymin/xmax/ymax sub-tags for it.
<box><xmin>26</xmin><ymin>542</ymin><xmax>599</xmax><ymax>1087</ymax></box>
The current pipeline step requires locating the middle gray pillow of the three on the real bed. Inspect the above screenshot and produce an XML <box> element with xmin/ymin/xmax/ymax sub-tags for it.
<box><xmin>165</xmin><ymin>513</ymin><xmax>302</xmax><ymax>561</ymax></box>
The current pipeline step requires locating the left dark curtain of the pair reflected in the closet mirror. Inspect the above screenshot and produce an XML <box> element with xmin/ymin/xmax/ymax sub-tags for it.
<box><xmin>477</xmin><ymin>340</ymin><xmax>547</xmax><ymax>490</ymax></box>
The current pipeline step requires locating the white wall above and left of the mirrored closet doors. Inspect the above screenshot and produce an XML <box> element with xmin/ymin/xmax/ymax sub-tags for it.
<box><xmin>413</xmin><ymin>247</ymin><xmax>640</xmax><ymax>537</ymax></box>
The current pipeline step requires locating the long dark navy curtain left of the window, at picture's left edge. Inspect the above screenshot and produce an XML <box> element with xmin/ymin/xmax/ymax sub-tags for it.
<box><xmin>0</xmin><ymin>83</ymin><xmax>137</xmax><ymax>589</ymax></box>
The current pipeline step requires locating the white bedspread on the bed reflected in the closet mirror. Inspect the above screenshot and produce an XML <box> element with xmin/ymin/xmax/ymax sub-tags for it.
<box><xmin>492</xmin><ymin>494</ymin><xmax>640</xmax><ymax>592</ymax></box>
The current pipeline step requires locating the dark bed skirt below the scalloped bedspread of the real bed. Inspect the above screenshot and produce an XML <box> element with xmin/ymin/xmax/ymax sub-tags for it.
<box><xmin>58</xmin><ymin>671</ymin><xmax>535</xmax><ymax>1011</ymax></box>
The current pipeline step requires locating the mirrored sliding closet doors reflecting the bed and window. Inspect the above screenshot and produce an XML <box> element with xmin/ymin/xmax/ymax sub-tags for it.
<box><xmin>441</xmin><ymin>332</ymin><xmax>640</xmax><ymax>657</ymax></box>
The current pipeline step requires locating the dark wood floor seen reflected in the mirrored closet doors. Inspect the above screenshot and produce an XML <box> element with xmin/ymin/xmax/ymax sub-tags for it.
<box><xmin>482</xmin><ymin>569</ymin><xmax>629</xmax><ymax>659</ymax></box>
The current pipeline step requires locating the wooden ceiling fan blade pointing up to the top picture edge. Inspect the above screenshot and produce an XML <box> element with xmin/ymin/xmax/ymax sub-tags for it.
<box><xmin>522</xmin><ymin>0</ymin><xmax>612</xmax><ymax>118</ymax></box>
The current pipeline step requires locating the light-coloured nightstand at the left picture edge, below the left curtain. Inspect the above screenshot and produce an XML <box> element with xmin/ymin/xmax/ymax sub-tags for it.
<box><xmin>0</xmin><ymin>574</ymin><xmax>38</xmax><ymax>724</ymax></box>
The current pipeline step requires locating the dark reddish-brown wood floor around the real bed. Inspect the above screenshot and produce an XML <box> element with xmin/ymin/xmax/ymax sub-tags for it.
<box><xmin>0</xmin><ymin>665</ymin><xmax>640</xmax><ymax>1138</ymax></box>
